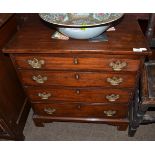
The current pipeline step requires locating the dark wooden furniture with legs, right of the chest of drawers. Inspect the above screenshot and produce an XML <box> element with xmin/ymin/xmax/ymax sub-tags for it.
<box><xmin>129</xmin><ymin>61</ymin><xmax>155</xmax><ymax>136</ymax></box>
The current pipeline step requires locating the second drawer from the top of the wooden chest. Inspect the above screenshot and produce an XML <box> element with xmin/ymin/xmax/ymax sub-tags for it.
<box><xmin>19</xmin><ymin>70</ymin><xmax>136</xmax><ymax>88</ymax></box>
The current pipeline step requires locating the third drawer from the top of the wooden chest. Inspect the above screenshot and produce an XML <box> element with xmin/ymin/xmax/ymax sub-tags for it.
<box><xmin>26</xmin><ymin>87</ymin><xmax>130</xmax><ymax>103</ymax></box>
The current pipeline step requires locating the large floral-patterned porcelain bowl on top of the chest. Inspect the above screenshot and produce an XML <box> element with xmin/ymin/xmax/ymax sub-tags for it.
<box><xmin>39</xmin><ymin>13</ymin><xmax>123</xmax><ymax>39</ymax></box>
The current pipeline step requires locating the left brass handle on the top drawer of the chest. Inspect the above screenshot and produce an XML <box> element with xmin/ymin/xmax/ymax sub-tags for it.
<box><xmin>27</xmin><ymin>58</ymin><xmax>45</xmax><ymax>68</ymax></box>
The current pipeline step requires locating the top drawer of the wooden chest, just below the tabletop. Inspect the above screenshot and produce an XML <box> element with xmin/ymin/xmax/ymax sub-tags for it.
<box><xmin>14</xmin><ymin>55</ymin><xmax>140</xmax><ymax>71</ymax></box>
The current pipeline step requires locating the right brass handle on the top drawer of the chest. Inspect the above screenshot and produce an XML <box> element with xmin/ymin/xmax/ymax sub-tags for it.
<box><xmin>109</xmin><ymin>60</ymin><xmax>127</xmax><ymax>71</ymax></box>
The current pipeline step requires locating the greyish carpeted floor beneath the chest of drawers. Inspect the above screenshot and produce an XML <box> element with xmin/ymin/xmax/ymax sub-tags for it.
<box><xmin>24</xmin><ymin>111</ymin><xmax>155</xmax><ymax>141</ymax></box>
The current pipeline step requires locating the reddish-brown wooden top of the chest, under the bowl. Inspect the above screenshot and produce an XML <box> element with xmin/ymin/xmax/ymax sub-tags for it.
<box><xmin>3</xmin><ymin>14</ymin><xmax>151</xmax><ymax>55</ymax></box>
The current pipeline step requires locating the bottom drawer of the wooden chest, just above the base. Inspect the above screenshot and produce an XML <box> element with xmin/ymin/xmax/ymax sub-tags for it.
<box><xmin>33</xmin><ymin>103</ymin><xmax>128</xmax><ymax>118</ymax></box>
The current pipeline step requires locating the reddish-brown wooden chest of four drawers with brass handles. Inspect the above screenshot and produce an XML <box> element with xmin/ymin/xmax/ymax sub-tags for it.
<box><xmin>3</xmin><ymin>14</ymin><xmax>150</xmax><ymax>130</ymax></box>
